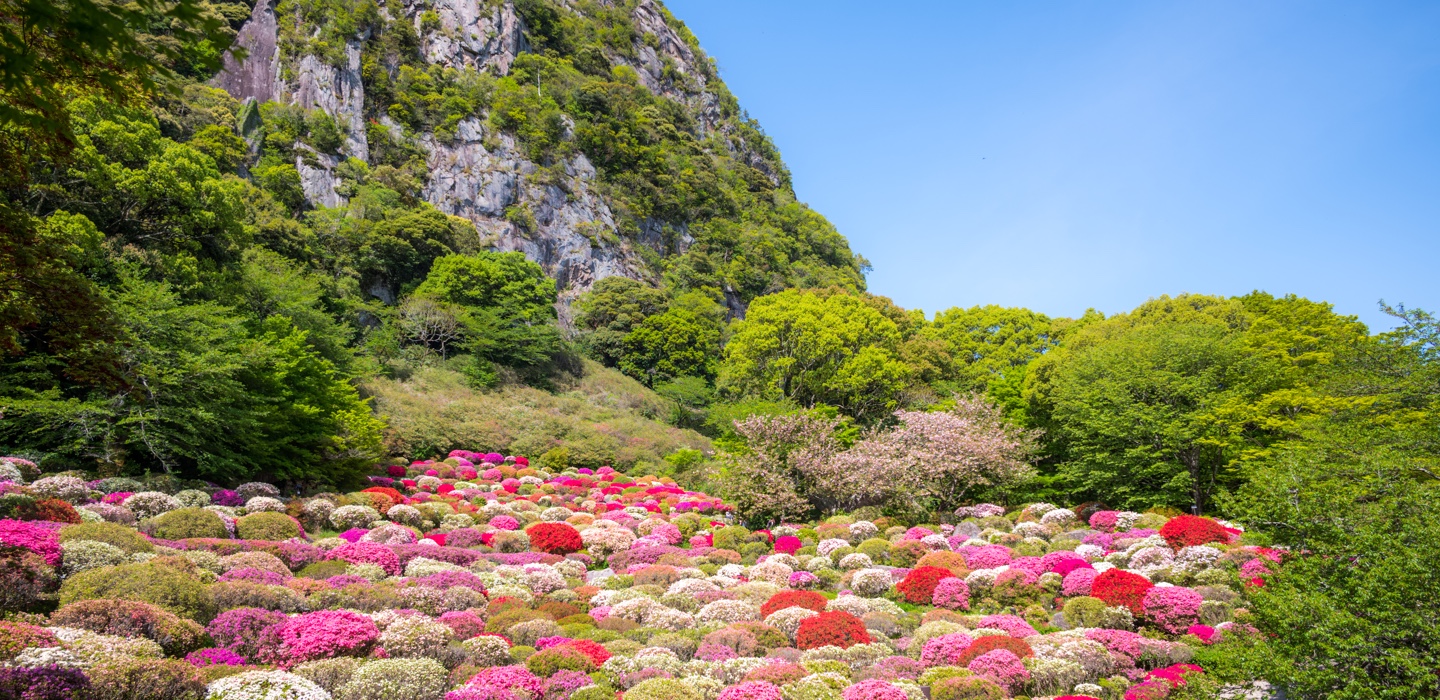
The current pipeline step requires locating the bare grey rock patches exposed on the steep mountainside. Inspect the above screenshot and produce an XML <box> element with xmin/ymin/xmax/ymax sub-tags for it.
<box><xmin>213</xmin><ymin>0</ymin><xmax>743</xmax><ymax>311</ymax></box>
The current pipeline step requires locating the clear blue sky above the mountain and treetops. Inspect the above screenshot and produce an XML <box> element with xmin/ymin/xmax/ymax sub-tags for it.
<box><xmin>667</xmin><ymin>0</ymin><xmax>1440</xmax><ymax>330</ymax></box>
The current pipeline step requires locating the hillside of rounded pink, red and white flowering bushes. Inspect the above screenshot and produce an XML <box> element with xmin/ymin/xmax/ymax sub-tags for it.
<box><xmin>0</xmin><ymin>451</ymin><xmax>1279</xmax><ymax>700</ymax></box>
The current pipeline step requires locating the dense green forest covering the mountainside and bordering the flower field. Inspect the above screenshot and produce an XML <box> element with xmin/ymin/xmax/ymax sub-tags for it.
<box><xmin>0</xmin><ymin>0</ymin><xmax>1440</xmax><ymax>699</ymax></box>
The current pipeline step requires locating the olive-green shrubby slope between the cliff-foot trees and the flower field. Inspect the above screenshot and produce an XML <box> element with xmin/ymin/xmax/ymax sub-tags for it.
<box><xmin>363</xmin><ymin>360</ymin><xmax>711</xmax><ymax>470</ymax></box>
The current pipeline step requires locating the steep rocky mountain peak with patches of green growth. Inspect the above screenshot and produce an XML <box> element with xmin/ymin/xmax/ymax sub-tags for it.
<box><xmin>212</xmin><ymin>0</ymin><xmax>865</xmax><ymax>324</ymax></box>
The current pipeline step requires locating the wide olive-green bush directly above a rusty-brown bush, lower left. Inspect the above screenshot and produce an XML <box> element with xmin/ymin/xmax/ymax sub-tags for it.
<box><xmin>60</xmin><ymin>558</ymin><xmax>216</xmax><ymax>622</ymax></box>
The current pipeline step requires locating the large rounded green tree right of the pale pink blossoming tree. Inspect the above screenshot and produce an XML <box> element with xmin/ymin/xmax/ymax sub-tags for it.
<box><xmin>1025</xmin><ymin>292</ymin><xmax>1365</xmax><ymax>510</ymax></box>
